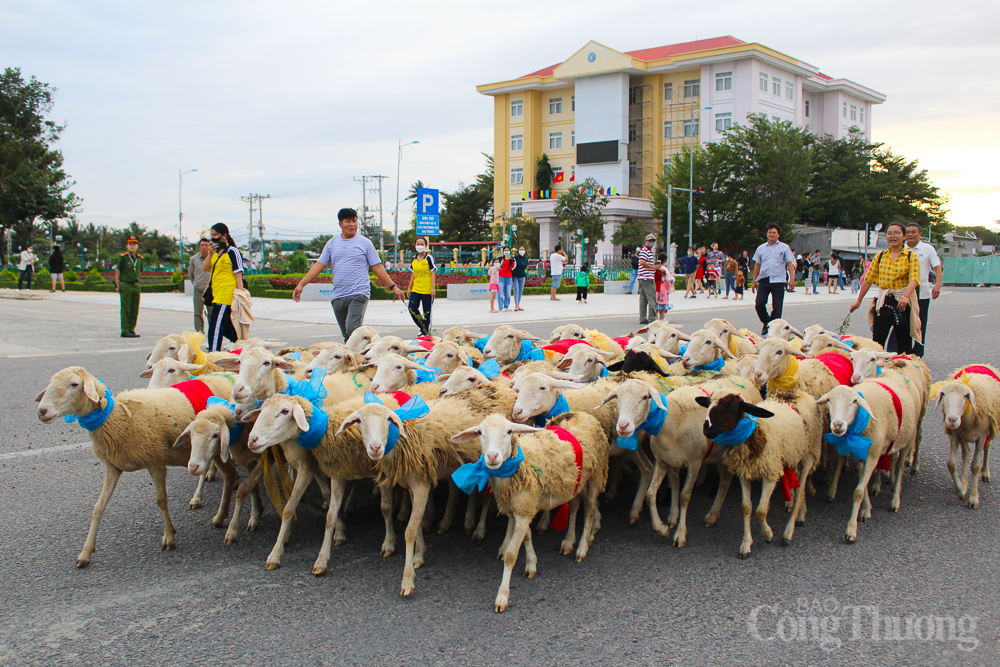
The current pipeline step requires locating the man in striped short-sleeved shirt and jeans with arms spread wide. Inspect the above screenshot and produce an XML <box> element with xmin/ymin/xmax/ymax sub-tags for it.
<box><xmin>292</xmin><ymin>208</ymin><xmax>406</xmax><ymax>342</ymax></box>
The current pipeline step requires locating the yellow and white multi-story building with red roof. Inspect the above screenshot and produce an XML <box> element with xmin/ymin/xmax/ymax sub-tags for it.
<box><xmin>477</xmin><ymin>37</ymin><xmax>885</xmax><ymax>262</ymax></box>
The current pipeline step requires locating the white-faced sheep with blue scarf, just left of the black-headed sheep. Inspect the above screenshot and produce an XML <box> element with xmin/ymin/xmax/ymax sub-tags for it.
<box><xmin>604</xmin><ymin>376</ymin><xmax>760</xmax><ymax>547</ymax></box>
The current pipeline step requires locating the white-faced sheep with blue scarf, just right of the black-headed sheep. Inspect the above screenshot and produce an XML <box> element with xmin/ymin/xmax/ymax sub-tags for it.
<box><xmin>817</xmin><ymin>378</ymin><xmax>917</xmax><ymax>542</ymax></box>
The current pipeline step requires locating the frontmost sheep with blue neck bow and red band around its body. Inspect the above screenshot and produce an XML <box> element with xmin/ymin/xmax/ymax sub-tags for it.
<box><xmin>452</xmin><ymin>412</ymin><xmax>608</xmax><ymax>613</ymax></box>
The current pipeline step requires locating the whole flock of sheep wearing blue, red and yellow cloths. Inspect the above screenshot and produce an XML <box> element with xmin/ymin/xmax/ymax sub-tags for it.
<box><xmin>36</xmin><ymin>319</ymin><xmax>1000</xmax><ymax>612</ymax></box>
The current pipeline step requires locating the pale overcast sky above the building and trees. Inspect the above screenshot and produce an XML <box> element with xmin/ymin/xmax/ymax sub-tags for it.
<box><xmin>0</xmin><ymin>0</ymin><xmax>1000</xmax><ymax>245</ymax></box>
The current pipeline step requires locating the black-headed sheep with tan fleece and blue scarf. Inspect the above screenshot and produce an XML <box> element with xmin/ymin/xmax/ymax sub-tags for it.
<box><xmin>695</xmin><ymin>388</ymin><xmax>822</xmax><ymax>558</ymax></box>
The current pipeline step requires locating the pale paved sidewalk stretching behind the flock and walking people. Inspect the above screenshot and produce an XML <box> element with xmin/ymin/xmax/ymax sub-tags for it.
<box><xmin>49</xmin><ymin>287</ymin><xmax>855</xmax><ymax>328</ymax></box>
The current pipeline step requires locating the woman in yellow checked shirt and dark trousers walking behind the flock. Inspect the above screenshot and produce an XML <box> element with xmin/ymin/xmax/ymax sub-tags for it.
<box><xmin>849</xmin><ymin>222</ymin><xmax>922</xmax><ymax>354</ymax></box>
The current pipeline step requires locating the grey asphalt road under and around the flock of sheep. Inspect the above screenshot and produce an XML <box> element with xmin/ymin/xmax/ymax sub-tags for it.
<box><xmin>0</xmin><ymin>289</ymin><xmax>1000</xmax><ymax>666</ymax></box>
